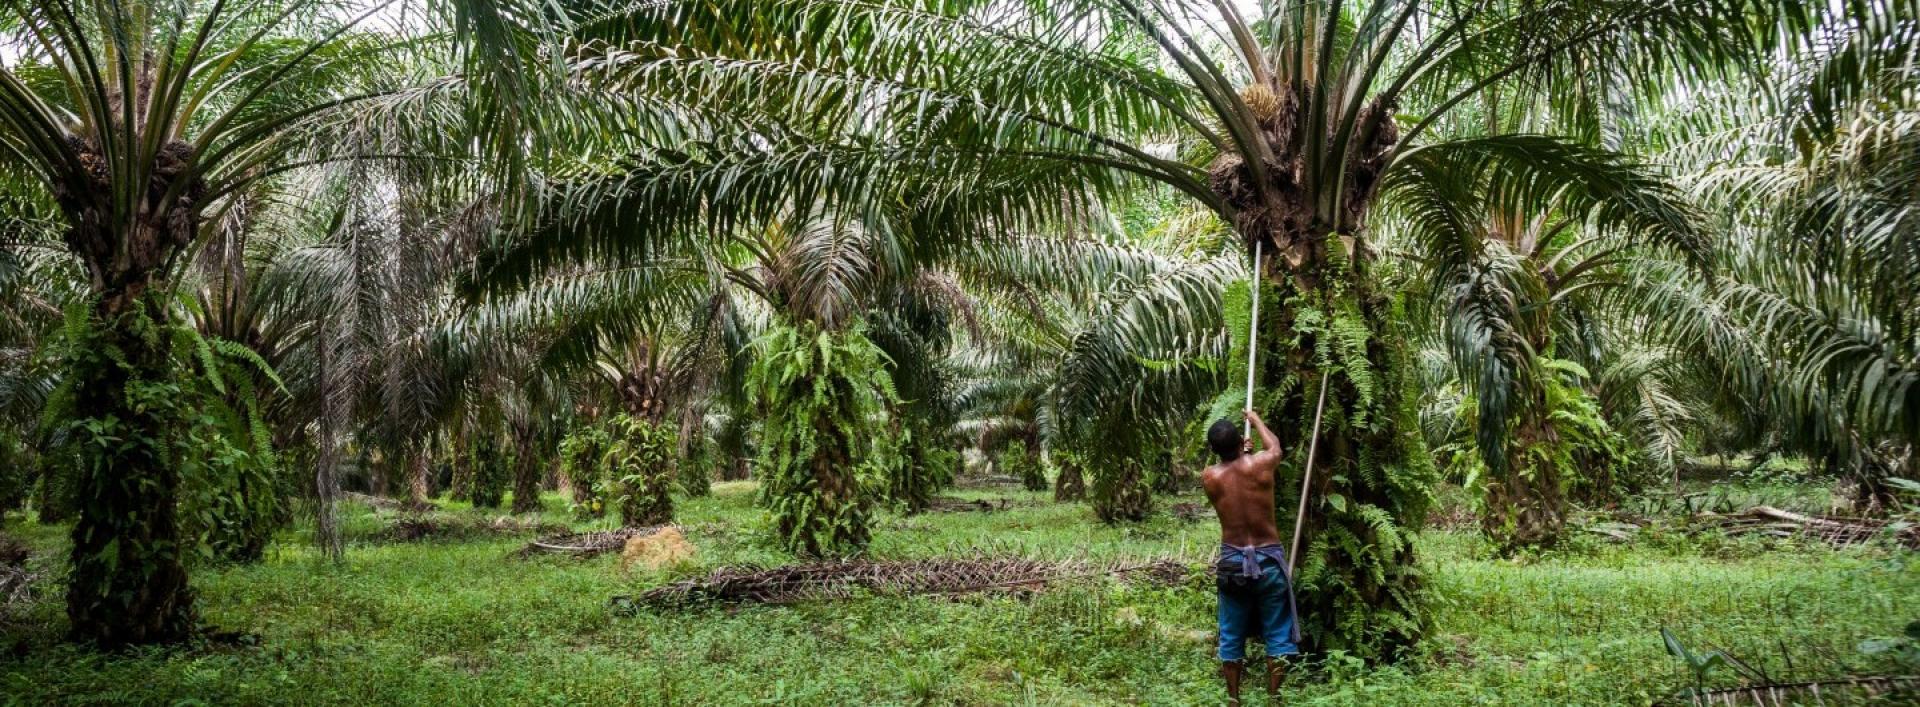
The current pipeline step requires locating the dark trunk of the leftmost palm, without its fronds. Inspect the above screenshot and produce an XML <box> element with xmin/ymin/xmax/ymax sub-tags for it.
<box><xmin>52</xmin><ymin>129</ymin><xmax>207</xmax><ymax>647</ymax></box>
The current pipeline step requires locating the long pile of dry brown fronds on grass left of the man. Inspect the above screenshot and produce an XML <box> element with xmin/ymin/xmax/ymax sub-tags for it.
<box><xmin>612</xmin><ymin>557</ymin><xmax>1187</xmax><ymax>611</ymax></box>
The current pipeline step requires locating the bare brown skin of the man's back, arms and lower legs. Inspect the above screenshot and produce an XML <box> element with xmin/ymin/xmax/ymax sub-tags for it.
<box><xmin>1200</xmin><ymin>409</ymin><xmax>1286</xmax><ymax>705</ymax></box>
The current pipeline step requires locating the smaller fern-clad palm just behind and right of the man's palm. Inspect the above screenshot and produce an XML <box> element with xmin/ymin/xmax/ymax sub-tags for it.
<box><xmin>1382</xmin><ymin>136</ymin><xmax>1707</xmax><ymax>548</ymax></box>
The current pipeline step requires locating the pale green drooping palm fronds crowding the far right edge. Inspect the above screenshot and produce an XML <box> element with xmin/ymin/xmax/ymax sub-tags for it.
<box><xmin>1644</xmin><ymin>0</ymin><xmax>1920</xmax><ymax>511</ymax></box>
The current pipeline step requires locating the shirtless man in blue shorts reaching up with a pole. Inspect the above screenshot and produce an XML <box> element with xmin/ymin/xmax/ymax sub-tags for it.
<box><xmin>1200</xmin><ymin>411</ymin><xmax>1300</xmax><ymax>705</ymax></box>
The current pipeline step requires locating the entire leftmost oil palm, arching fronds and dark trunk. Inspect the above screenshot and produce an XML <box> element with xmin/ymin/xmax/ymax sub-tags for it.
<box><xmin>0</xmin><ymin>0</ymin><xmax>556</xmax><ymax>646</ymax></box>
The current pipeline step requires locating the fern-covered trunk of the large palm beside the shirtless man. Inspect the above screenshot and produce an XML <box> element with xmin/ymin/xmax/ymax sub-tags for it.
<box><xmin>1256</xmin><ymin>236</ymin><xmax>1438</xmax><ymax>659</ymax></box>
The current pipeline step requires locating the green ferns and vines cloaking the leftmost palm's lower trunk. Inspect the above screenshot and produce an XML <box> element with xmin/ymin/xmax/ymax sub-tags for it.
<box><xmin>42</xmin><ymin>298</ymin><xmax>286</xmax><ymax>647</ymax></box>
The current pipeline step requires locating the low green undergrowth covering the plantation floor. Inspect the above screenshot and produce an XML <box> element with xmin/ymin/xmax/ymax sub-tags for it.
<box><xmin>0</xmin><ymin>482</ymin><xmax>1920</xmax><ymax>705</ymax></box>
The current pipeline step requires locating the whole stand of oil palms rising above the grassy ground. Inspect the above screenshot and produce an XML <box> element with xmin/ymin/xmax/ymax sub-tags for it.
<box><xmin>0</xmin><ymin>0</ymin><xmax>1920</xmax><ymax>657</ymax></box>
